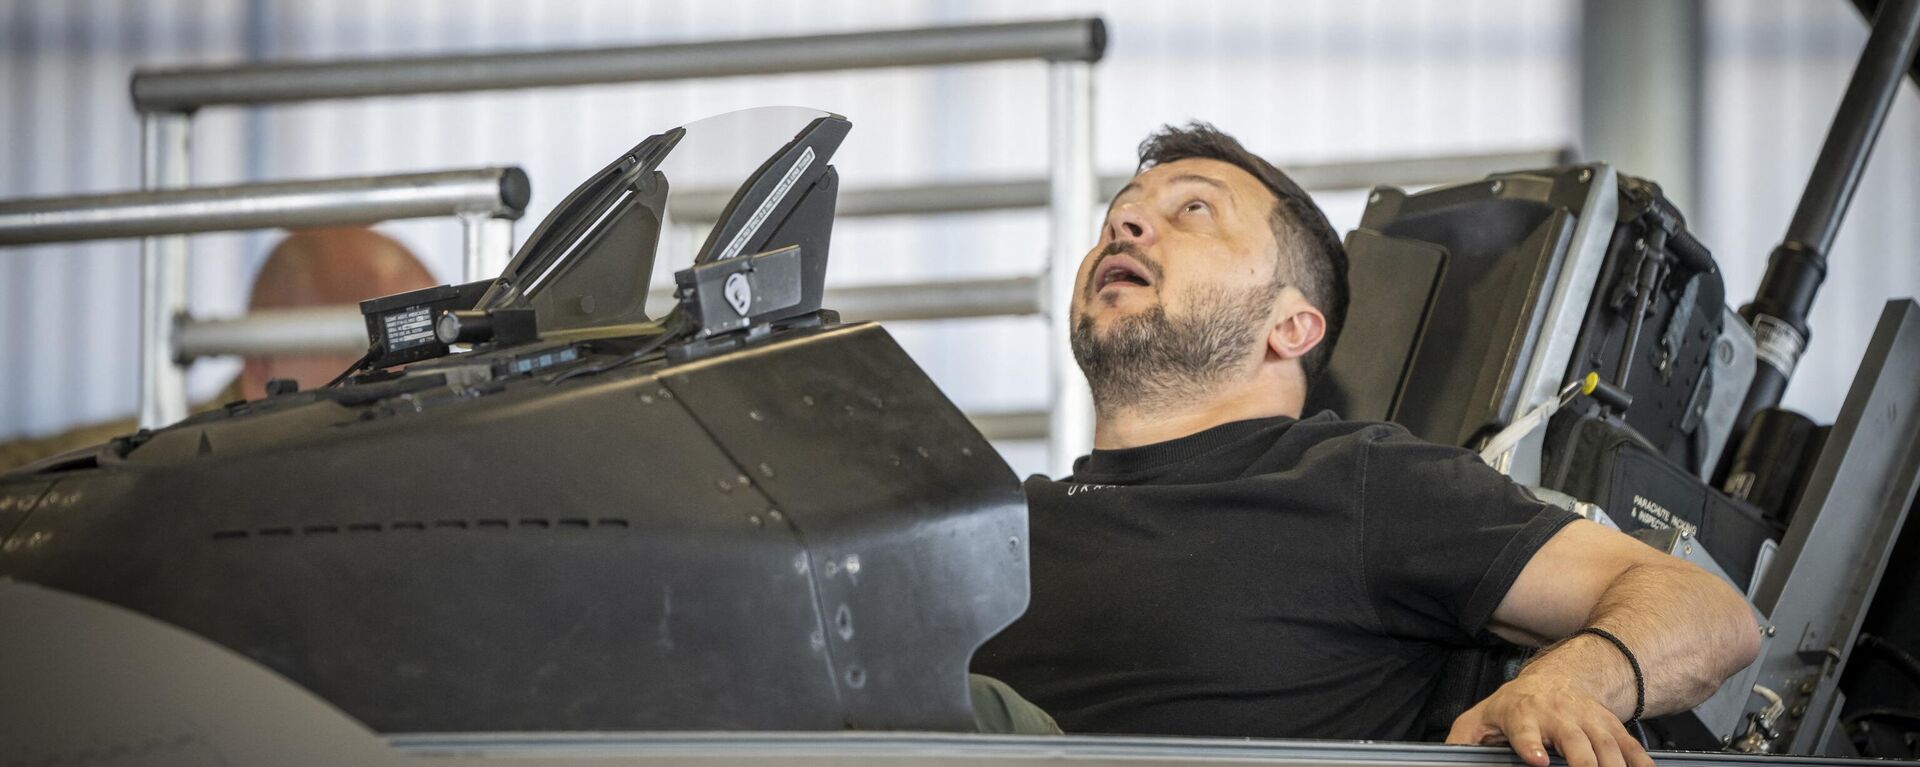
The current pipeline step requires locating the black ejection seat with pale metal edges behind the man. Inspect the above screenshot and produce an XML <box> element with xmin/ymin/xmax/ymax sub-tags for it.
<box><xmin>1306</xmin><ymin>163</ymin><xmax>1778</xmax><ymax>738</ymax></box>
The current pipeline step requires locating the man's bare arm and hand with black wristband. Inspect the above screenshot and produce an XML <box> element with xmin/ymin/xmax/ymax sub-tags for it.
<box><xmin>1448</xmin><ymin>521</ymin><xmax>1761</xmax><ymax>767</ymax></box>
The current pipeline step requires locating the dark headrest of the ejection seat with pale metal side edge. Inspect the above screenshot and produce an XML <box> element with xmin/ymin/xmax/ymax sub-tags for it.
<box><xmin>1308</xmin><ymin>163</ymin><xmax>1615</xmax><ymax>444</ymax></box>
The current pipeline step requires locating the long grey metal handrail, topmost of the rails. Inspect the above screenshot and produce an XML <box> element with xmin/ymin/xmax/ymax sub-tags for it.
<box><xmin>132</xmin><ymin>17</ymin><xmax>1106</xmax><ymax>113</ymax></box>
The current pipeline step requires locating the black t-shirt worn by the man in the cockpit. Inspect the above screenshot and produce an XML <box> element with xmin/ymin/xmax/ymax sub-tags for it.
<box><xmin>973</xmin><ymin>413</ymin><xmax>1574</xmax><ymax>740</ymax></box>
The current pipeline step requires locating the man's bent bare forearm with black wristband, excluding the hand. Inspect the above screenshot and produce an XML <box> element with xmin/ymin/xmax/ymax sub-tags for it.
<box><xmin>1521</xmin><ymin>563</ymin><xmax>1761</xmax><ymax>719</ymax></box>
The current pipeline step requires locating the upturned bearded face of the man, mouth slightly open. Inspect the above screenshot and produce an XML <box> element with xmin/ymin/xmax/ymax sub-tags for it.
<box><xmin>1071</xmin><ymin>160</ymin><xmax>1281</xmax><ymax>406</ymax></box>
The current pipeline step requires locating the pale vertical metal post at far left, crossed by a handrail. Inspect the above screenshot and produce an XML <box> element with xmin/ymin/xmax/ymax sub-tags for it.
<box><xmin>140</xmin><ymin>113</ymin><xmax>192</xmax><ymax>429</ymax></box>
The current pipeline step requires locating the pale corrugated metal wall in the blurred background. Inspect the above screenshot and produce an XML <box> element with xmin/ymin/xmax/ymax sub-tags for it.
<box><xmin>18</xmin><ymin>0</ymin><xmax>1920</xmax><ymax>469</ymax></box>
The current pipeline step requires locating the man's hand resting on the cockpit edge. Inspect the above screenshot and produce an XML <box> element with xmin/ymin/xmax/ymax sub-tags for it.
<box><xmin>1446</xmin><ymin>673</ymin><xmax>1653</xmax><ymax>767</ymax></box>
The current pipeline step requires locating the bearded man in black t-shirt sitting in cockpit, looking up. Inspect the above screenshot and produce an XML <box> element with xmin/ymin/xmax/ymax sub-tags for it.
<box><xmin>973</xmin><ymin>123</ymin><xmax>1759</xmax><ymax>767</ymax></box>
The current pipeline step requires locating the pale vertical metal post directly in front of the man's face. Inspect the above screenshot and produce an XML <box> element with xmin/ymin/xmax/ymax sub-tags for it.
<box><xmin>1044</xmin><ymin>62</ymin><xmax>1098</xmax><ymax>477</ymax></box>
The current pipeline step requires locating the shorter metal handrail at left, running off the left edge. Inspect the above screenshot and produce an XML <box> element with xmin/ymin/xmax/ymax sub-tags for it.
<box><xmin>0</xmin><ymin>167</ymin><xmax>530</xmax><ymax>246</ymax></box>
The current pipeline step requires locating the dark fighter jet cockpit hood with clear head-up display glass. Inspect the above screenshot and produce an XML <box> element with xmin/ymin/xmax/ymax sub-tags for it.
<box><xmin>0</xmin><ymin>108</ymin><xmax>1027</xmax><ymax>734</ymax></box>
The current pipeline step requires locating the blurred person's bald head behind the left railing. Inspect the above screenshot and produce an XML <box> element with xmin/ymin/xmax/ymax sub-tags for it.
<box><xmin>240</xmin><ymin>227</ymin><xmax>438</xmax><ymax>400</ymax></box>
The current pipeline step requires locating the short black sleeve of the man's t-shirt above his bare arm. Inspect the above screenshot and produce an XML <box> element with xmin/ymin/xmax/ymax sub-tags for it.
<box><xmin>1361</xmin><ymin>429</ymin><xmax>1576</xmax><ymax>644</ymax></box>
